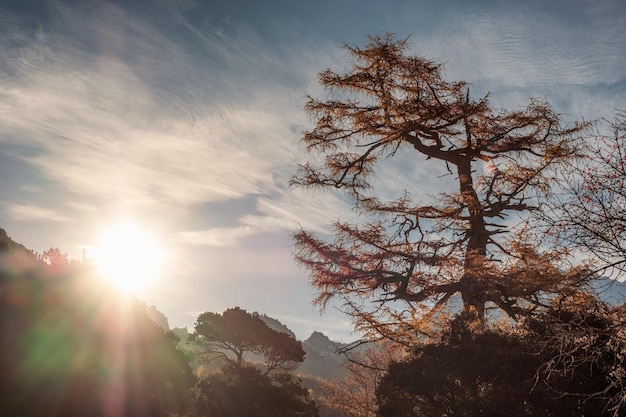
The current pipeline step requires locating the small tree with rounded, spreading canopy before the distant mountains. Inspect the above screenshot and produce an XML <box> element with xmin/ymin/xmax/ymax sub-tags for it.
<box><xmin>194</xmin><ymin>307</ymin><xmax>304</xmax><ymax>373</ymax></box>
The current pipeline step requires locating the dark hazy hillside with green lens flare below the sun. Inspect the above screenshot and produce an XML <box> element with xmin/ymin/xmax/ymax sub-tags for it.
<box><xmin>0</xmin><ymin>230</ymin><xmax>194</xmax><ymax>417</ymax></box>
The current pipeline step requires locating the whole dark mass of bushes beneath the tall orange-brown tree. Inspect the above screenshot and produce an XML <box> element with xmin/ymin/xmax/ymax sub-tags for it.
<box><xmin>376</xmin><ymin>300</ymin><xmax>625</xmax><ymax>417</ymax></box>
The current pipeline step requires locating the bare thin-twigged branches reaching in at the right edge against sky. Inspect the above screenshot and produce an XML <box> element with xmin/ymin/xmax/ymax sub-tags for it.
<box><xmin>549</xmin><ymin>111</ymin><xmax>626</xmax><ymax>277</ymax></box>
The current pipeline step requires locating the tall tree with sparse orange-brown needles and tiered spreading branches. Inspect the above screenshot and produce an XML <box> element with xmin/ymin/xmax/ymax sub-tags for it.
<box><xmin>292</xmin><ymin>35</ymin><xmax>587</xmax><ymax>339</ymax></box>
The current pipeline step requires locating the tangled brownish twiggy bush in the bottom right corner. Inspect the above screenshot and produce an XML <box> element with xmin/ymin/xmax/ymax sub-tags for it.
<box><xmin>525</xmin><ymin>294</ymin><xmax>626</xmax><ymax>417</ymax></box>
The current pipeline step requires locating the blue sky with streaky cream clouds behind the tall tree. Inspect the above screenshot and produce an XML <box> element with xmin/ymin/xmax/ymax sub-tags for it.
<box><xmin>0</xmin><ymin>0</ymin><xmax>626</xmax><ymax>342</ymax></box>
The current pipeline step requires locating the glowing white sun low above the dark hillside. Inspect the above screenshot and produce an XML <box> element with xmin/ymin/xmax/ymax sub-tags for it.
<box><xmin>94</xmin><ymin>222</ymin><xmax>163</xmax><ymax>293</ymax></box>
